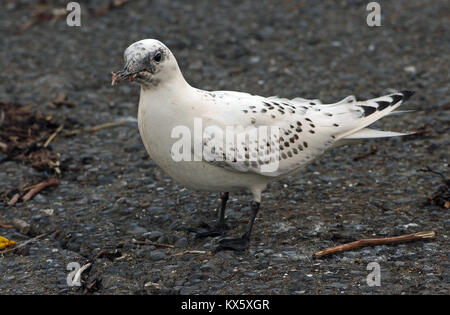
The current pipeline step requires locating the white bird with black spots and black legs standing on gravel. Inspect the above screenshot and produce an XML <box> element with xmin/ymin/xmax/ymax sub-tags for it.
<box><xmin>112</xmin><ymin>39</ymin><xmax>413</xmax><ymax>250</ymax></box>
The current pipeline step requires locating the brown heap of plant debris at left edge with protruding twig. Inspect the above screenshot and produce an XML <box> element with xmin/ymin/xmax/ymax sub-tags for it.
<box><xmin>0</xmin><ymin>101</ymin><xmax>133</xmax><ymax>206</ymax></box>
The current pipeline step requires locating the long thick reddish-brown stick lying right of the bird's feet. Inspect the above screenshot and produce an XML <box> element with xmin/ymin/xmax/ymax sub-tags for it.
<box><xmin>314</xmin><ymin>231</ymin><xmax>436</xmax><ymax>258</ymax></box>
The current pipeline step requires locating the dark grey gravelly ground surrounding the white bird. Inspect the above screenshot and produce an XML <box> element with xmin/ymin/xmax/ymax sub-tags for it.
<box><xmin>0</xmin><ymin>0</ymin><xmax>450</xmax><ymax>294</ymax></box>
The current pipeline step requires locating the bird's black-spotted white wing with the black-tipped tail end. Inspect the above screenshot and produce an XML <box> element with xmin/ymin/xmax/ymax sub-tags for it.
<box><xmin>193</xmin><ymin>91</ymin><xmax>412</xmax><ymax>177</ymax></box>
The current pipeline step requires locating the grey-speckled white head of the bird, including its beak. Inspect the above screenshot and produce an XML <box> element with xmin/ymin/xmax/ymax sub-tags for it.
<box><xmin>113</xmin><ymin>39</ymin><xmax>173</xmax><ymax>87</ymax></box>
